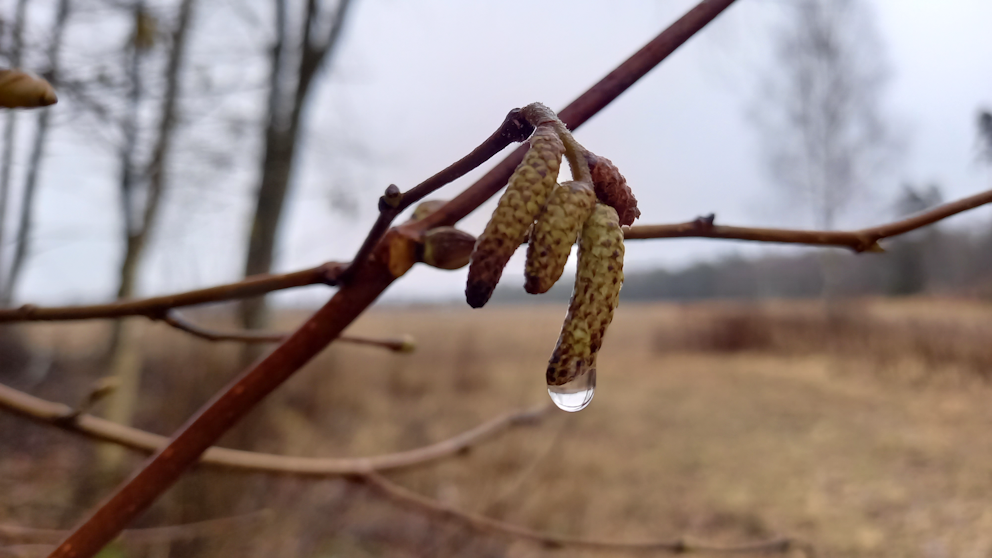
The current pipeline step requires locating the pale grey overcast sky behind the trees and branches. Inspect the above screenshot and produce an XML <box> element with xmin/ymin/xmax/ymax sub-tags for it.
<box><xmin>9</xmin><ymin>0</ymin><xmax>992</xmax><ymax>302</ymax></box>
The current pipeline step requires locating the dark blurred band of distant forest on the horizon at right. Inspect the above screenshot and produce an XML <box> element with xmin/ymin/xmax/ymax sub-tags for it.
<box><xmin>494</xmin><ymin>221</ymin><xmax>992</xmax><ymax>303</ymax></box>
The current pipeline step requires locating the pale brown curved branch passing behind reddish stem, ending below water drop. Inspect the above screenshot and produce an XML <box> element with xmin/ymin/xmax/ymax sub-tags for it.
<box><xmin>0</xmin><ymin>384</ymin><xmax>550</xmax><ymax>477</ymax></box>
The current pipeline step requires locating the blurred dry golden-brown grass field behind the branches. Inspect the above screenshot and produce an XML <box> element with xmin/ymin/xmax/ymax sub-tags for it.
<box><xmin>0</xmin><ymin>300</ymin><xmax>992</xmax><ymax>558</ymax></box>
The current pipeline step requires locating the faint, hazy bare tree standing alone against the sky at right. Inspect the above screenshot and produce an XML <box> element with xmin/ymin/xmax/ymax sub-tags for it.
<box><xmin>756</xmin><ymin>0</ymin><xmax>892</xmax><ymax>229</ymax></box>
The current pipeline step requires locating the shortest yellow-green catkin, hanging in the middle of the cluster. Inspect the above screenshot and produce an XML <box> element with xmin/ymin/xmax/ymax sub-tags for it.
<box><xmin>524</xmin><ymin>182</ymin><xmax>596</xmax><ymax>294</ymax></box>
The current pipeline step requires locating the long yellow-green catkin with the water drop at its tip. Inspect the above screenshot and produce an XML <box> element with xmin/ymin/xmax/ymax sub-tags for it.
<box><xmin>547</xmin><ymin>203</ymin><xmax>623</xmax><ymax>386</ymax></box>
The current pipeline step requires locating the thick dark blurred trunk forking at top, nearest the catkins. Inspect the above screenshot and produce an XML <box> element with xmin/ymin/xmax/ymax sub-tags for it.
<box><xmin>241</xmin><ymin>0</ymin><xmax>351</xmax><ymax>329</ymax></box>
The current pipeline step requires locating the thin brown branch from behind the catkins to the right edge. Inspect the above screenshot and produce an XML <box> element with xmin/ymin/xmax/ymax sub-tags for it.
<box><xmin>624</xmin><ymin>190</ymin><xmax>992</xmax><ymax>252</ymax></box>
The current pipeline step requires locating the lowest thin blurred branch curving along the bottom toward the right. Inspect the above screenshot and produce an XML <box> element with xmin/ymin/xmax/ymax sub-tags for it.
<box><xmin>360</xmin><ymin>473</ymin><xmax>811</xmax><ymax>556</ymax></box>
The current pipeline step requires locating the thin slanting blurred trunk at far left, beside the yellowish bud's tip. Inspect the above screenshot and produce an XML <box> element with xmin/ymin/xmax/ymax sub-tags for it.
<box><xmin>0</xmin><ymin>0</ymin><xmax>69</xmax><ymax>306</ymax></box>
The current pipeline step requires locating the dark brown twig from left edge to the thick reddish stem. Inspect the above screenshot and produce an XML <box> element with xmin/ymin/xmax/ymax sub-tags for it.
<box><xmin>0</xmin><ymin>262</ymin><xmax>346</xmax><ymax>323</ymax></box>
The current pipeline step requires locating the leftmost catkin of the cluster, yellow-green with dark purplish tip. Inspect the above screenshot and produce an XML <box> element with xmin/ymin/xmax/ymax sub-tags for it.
<box><xmin>465</xmin><ymin>124</ymin><xmax>565</xmax><ymax>308</ymax></box>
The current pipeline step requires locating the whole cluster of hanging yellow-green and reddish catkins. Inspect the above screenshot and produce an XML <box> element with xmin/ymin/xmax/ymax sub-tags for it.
<box><xmin>465</xmin><ymin>104</ymin><xmax>628</xmax><ymax>404</ymax></box>
